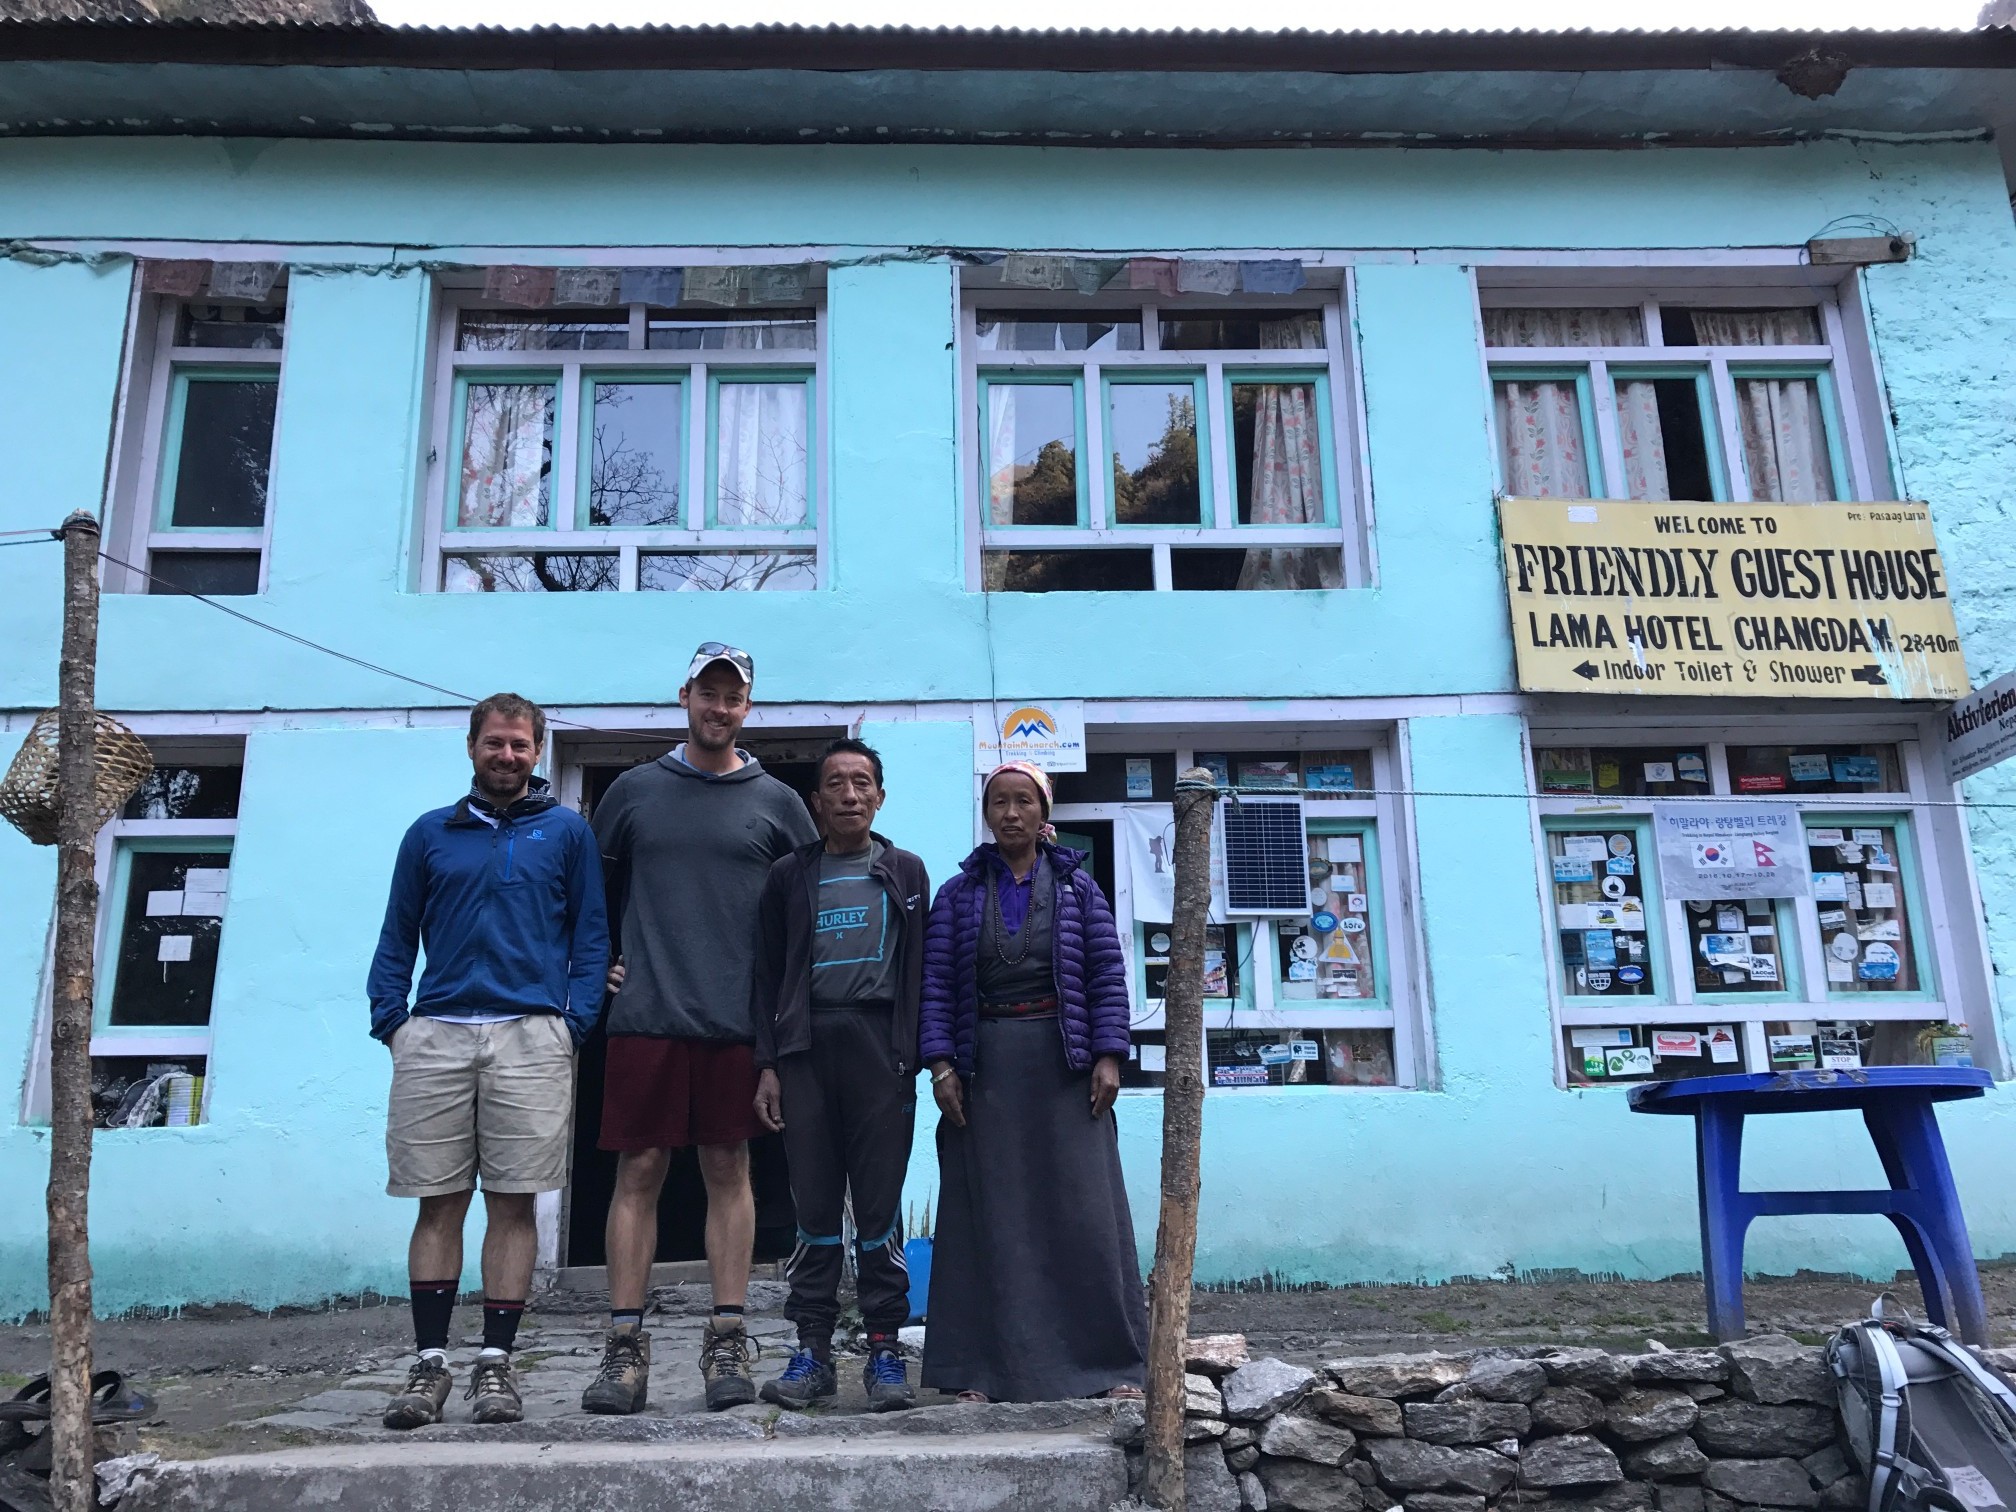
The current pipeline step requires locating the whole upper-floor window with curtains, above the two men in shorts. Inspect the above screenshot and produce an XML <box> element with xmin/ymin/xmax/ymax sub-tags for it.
<box><xmin>427</xmin><ymin>290</ymin><xmax>823</xmax><ymax>593</ymax></box>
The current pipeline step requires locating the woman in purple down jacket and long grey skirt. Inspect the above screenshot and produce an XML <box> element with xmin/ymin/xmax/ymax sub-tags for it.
<box><xmin>919</xmin><ymin>762</ymin><xmax>1147</xmax><ymax>1401</ymax></box>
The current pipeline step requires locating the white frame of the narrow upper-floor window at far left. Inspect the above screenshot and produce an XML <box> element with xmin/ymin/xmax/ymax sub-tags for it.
<box><xmin>103</xmin><ymin>278</ymin><xmax>292</xmax><ymax>593</ymax></box>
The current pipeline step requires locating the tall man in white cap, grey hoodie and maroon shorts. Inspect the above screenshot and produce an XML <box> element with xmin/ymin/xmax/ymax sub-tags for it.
<box><xmin>581</xmin><ymin>641</ymin><xmax>818</xmax><ymax>1413</ymax></box>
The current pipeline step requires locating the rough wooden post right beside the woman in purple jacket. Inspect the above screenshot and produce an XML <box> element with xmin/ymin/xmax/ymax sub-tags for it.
<box><xmin>1141</xmin><ymin>766</ymin><xmax>1218</xmax><ymax>1512</ymax></box>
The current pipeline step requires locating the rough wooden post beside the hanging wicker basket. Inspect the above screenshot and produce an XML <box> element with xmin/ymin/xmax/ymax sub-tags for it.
<box><xmin>48</xmin><ymin>512</ymin><xmax>99</xmax><ymax>1512</ymax></box>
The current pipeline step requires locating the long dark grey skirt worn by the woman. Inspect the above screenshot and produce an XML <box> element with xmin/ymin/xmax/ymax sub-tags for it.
<box><xmin>921</xmin><ymin>1016</ymin><xmax>1147</xmax><ymax>1401</ymax></box>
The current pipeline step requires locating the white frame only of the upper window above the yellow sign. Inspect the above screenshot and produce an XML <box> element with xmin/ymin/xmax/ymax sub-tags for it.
<box><xmin>1478</xmin><ymin>286</ymin><xmax>1893</xmax><ymax>504</ymax></box>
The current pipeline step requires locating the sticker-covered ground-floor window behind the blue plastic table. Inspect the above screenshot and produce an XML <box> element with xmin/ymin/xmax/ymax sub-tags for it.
<box><xmin>1534</xmin><ymin>730</ymin><xmax>1994</xmax><ymax>1085</ymax></box>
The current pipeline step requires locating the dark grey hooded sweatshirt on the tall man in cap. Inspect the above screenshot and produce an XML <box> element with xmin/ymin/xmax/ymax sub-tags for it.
<box><xmin>595</xmin><ymin>752</ymin><xmax>818</xmax><ymax>1044</ymax></box>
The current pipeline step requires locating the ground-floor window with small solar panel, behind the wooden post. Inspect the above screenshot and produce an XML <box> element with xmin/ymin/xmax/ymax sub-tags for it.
<box><xmin>1054</xmin><ymin>728</ymin><xmax>1423</xmax><ymax>1091</ymax></box>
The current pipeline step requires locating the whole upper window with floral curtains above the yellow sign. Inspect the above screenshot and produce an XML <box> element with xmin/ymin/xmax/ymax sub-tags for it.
<box><xmin>1482</xmin><ymin>290</ymin><xmax>1887</xmax><ymax>504</ymax></box>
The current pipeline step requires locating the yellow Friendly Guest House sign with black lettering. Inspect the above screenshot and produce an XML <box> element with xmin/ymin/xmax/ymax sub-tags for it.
<box><xmin>1498</xmin><ymin>498</ymin><xmax>1968</xmax><ymax>700</ymax></box>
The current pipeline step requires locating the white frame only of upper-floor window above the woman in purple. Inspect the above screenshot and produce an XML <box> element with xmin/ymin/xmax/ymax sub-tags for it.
<box><xmin>960</xmin><ymin>278</ymin><xmax>1373</xmax><ymax>593</ymax></box>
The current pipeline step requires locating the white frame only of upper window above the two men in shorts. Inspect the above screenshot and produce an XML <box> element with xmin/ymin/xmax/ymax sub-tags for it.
<box><xmin>417</xmin><ymin>288</ymin><xmax>831</xmax><ymax>593</ymax></box>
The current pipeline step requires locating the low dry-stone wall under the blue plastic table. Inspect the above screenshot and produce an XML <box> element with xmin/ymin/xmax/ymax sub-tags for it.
<box><xmin>1113</xmin><ymin>1335</ymin><xmax>2006</xmax><ymax>1512</ymax></box>
